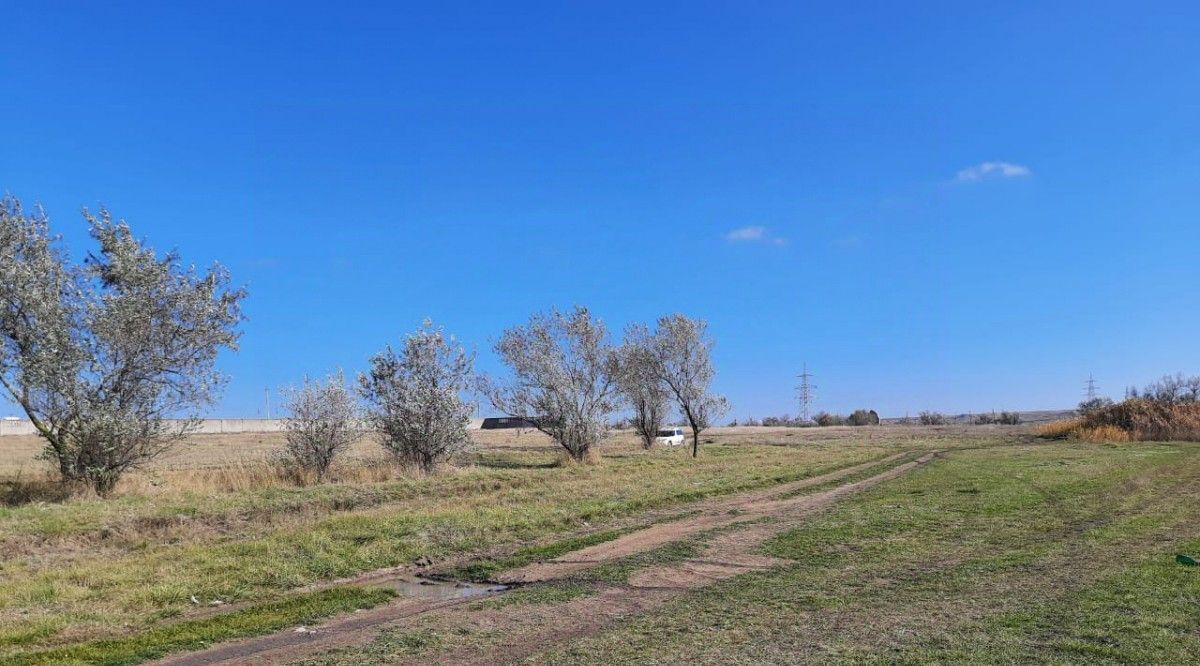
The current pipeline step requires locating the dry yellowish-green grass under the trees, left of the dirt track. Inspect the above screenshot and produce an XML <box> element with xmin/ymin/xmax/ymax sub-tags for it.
<box><xmin>0</xmin><ymin>428</ymin><xmax>955</xmax><ymax>659</ymax></box>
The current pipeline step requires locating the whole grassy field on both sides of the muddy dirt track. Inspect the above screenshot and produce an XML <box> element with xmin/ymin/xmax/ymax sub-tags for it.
<box><xmin>9</xmin><ymin>427</ymin><xmax>1200</xmax><ymax>664</ymax></box>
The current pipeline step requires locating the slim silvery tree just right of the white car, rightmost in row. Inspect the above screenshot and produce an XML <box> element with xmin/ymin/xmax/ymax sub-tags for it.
<box><xmin>654</xmin><ymin>314</ymin><xmax>728</xmax><ymax>457</ymax></box>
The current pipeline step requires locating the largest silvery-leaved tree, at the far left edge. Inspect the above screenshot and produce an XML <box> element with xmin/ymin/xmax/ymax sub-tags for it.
<box><xmin>0</xmin><ymin>197</ymin><xmax>245</xmax><ymax>494</ymax></box>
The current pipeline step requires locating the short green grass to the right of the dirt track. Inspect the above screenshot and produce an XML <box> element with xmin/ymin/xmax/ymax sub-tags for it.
<box><xmin>532</xmin><ymin>443</ymin><xmax>1200</xmax><ymax>664</ymax></box>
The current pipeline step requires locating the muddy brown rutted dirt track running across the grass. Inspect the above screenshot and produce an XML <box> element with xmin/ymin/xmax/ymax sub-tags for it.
<box><xmin>155</xmin><ymin>451</ymin><xmax>941</xmax><ymax>666</ymax></box>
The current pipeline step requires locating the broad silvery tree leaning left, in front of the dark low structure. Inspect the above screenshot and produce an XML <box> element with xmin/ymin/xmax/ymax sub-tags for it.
<box><xmin>481</xmin><ymin>306</ymin><xmax>620</xmax><ymax>461</ymax></box>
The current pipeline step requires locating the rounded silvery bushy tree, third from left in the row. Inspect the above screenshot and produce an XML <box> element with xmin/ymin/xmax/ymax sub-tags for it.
<box><xmin>359</xmin><ymin>319</ymin><xmax>474</xmax><ymax>472</ymax></box>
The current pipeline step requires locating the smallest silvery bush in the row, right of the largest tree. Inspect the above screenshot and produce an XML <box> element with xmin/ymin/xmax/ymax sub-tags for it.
<box><xmin>283</xmin><ymin>370</ymin><xmax>366</xmax><ymax>482</ymax></box>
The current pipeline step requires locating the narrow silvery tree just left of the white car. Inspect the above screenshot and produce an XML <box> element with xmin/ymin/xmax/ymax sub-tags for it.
<box><xmin>617</xmin><ymin>324</ymin><xmax>671</xmax><ymax>449</ymax></box>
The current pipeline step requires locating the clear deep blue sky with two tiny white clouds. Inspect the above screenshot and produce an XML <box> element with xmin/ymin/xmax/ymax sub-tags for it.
<box><xmin>0</xmin><ymin>1</ymin><xmax>1200</xmax><ymax>418</ymax></box>
